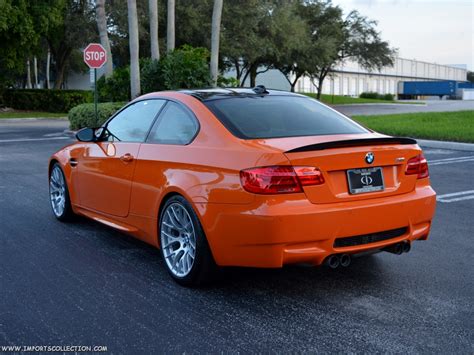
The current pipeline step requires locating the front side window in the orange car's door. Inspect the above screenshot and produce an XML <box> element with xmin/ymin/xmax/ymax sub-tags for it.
<box><xmin>107</xmin><ymin>100</ymin><xmax>165</xmax><ymax>142</ymax></box>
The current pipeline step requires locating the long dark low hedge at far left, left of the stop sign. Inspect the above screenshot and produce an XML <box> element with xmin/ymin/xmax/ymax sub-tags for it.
<box><xmin>2</xmin><ymin>89</ymin><xmax>93</xmax><ymax>112</ymax></box>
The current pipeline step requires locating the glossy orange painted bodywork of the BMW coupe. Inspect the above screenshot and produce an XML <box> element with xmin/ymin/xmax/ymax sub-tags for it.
<box><xmin>51</xmin><ymin>92</ymin><xmax>436</xmax><ymax>267</ymax></box>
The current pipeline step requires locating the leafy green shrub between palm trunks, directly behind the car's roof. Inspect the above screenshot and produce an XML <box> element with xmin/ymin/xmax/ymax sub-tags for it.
<box><xmin>141</xmin><ymin>45</ymin><xmax>211</xmax><ymax>93</ymax></box>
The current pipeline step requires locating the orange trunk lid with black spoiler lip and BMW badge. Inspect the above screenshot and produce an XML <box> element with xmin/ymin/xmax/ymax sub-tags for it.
<box><xmin>284</xmin><ymin>137</ymin><xmax>421</xmax><ymax>203</ymax></box>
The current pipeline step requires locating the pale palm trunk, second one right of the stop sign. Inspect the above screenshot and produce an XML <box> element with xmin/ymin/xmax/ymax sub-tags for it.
<box><xmin>127</xmin><ymin>0</ymin><xmax>140</xmax><ymax>99</ymax></box>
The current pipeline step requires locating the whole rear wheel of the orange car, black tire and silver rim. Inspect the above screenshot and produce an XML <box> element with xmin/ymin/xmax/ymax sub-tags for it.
<box><xmin>158</xmin><ymin>195</ymin><xmax>217</xmax><ymax>286</ymax></box>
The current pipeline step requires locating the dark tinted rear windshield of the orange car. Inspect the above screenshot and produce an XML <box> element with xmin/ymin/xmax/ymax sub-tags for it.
<box><xmin>204</xmin><ymin>96</ymin><xmax>368</xmax><ymax>139</ymax></box>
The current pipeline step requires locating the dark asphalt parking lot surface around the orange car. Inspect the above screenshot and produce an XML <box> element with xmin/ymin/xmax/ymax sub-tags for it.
<box><xmin>0</xmin><ymin>120</ymin><xmax>474</xmax><ymax>354</ymax></box>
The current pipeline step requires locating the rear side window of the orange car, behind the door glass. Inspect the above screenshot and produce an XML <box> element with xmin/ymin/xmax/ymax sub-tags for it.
<box><xmin>147</xmin><ymin>101</ymin><xmax>198</xmax><ymax>145</ymax></box>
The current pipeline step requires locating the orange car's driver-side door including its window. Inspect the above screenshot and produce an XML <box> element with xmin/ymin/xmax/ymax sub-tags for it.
<box><xmin>76</xmin><ymin>99</ymin><xmax>165</xmax><ymax>217</ymax></box>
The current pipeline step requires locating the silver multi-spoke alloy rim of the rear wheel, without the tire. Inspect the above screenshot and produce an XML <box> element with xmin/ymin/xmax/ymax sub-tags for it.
<box><xmin>160</xmin><ymin>202</ymin><xmax>196</xmax><ymax>277</ymax></box>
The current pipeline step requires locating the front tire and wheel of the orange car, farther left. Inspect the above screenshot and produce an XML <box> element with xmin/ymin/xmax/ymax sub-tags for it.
<box><xmin>49</xmin><ymin>163</ymin><xmax>75</xmax><ymax>222</ymax></box>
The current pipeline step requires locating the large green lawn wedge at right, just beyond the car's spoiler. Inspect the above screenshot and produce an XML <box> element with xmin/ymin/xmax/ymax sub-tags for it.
<box><xmin>352</xmin><ymin>111</ymin><xmax>474</xmax><ymax>143</ymax></box>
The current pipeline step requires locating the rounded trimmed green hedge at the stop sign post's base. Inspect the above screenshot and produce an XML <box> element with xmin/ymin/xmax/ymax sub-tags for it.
<box><xmin>68</xmin><ymin>102</ymin><xmax>125</xmax><ymax>130</ymax></box>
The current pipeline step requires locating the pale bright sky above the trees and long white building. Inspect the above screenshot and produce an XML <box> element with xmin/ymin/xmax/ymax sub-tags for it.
<box><xmin>333</xmin><ymin>0</ymin><xmax>474</xmax><ymax>70</ymax></box>
